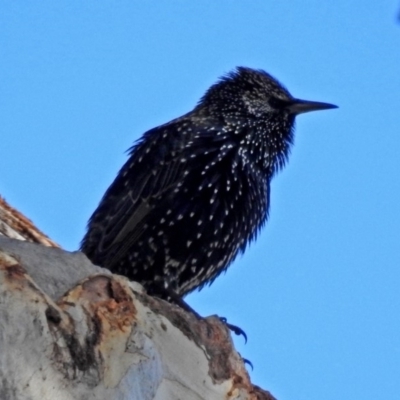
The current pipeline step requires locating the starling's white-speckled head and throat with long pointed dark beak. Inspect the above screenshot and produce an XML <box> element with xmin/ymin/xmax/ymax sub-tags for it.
<box><xmin>194</xmin><ymin>67</ymin><xmax>336</xmax><ymax>176</ymax></box>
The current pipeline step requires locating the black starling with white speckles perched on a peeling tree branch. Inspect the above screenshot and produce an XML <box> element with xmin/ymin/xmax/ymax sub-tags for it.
<box><xmin>81</xmin><ymin>67</ymin><xmax>336</xmax><ymax>298</ymax></box>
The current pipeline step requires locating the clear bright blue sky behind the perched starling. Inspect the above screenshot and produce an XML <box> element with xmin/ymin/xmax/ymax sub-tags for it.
<box><xmin>0</xmin><ymin>0</ymin><xmax>400</xmax><ymax>400</ymax></box>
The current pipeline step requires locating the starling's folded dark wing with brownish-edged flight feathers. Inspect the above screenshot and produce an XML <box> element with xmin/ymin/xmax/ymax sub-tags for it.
<box><xmin>82</xmin><ymin>121</ymin><xmax>191</xmax><ymax>268</ymax></box>
